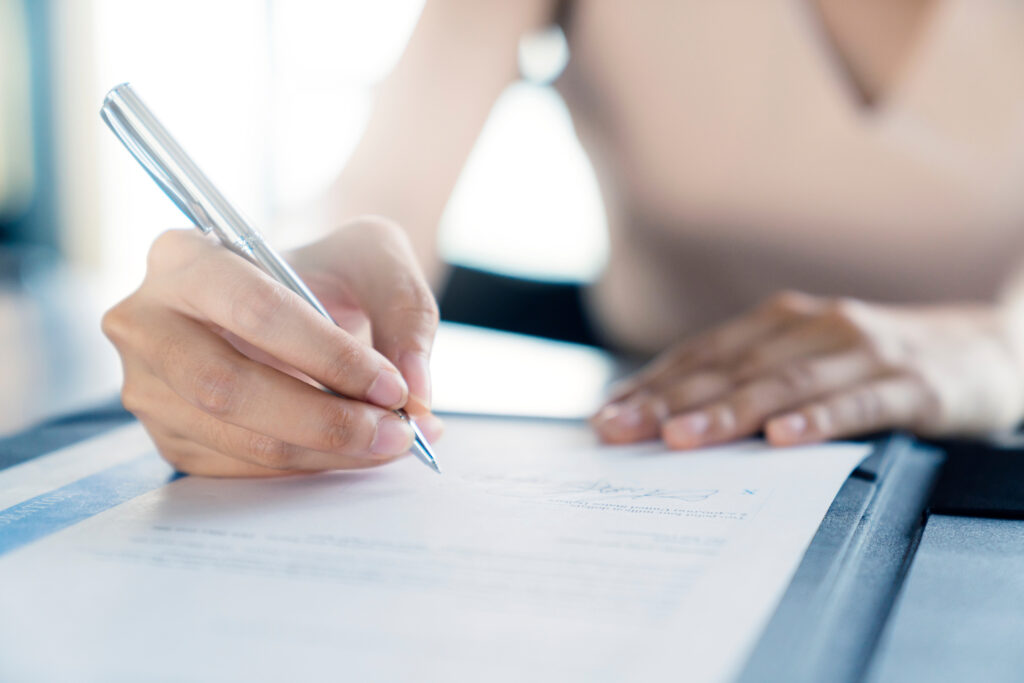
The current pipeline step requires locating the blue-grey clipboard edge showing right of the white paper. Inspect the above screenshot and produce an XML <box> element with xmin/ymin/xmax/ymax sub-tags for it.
<box><xmin>737</xmin><ymin>434</ymin><xmax>944</xmax><ymax>683</ymax></box>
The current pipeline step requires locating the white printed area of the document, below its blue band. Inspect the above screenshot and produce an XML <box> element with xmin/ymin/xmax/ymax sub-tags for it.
<box><xmin>0</xmin><ymin>418</ymin><xmax>868</xmax><ymax>682</ymax></box>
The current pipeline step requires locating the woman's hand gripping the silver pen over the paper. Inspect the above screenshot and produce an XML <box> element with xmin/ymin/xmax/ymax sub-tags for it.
<box><xmin>103</xmin><ymin>218</ymin><xmax>440</xmax><ymax>476</ymax></box>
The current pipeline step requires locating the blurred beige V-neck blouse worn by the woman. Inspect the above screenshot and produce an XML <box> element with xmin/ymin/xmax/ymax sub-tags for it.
<box><xmin>557</xmin><ymin>0</ymin><xmax>1024</xmax><ymax>351</ymax></box>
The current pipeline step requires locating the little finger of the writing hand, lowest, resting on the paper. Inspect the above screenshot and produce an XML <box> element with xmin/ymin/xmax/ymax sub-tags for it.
<box><xmin>136</xmin><ymin>378</ymin><xmax>409</xmax><ymax>476</ymax></box>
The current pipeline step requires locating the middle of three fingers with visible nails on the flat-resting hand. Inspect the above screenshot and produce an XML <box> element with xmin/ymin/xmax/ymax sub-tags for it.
<box><xmin>662</xmin><ymin>350</ymin><xmax>880</xmax><ymax>449</ymax></box>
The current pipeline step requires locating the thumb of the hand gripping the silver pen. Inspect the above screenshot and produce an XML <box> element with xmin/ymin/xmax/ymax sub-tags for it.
<box><xmin>321</xmin><ymin>218</ymin><xmax>438</xmax><ymax>415</ymax></box>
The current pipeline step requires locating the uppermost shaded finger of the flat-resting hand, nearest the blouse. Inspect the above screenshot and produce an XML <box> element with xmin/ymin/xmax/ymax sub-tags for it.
<box><xmin>609</xmin><ymin>292</ymin><xmax>823</xmax><ymax>402</ymax></box>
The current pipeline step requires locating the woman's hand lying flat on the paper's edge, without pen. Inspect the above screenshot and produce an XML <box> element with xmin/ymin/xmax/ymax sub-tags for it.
<box><xmin>593</xmin><ymin>293</ymin><xmax>1024</xmax><ymax>449</ymax></box>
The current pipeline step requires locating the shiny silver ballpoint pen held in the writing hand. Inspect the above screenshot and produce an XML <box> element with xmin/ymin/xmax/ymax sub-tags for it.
<box><xmin>99</xmin><ymin>83</ymin><xmax>441</xmax><ymax>474</ymax></box>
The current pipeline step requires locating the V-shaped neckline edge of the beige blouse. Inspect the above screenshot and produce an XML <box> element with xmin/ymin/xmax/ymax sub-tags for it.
<box><xmin>798</xmin><ymin>0</ymin><xmax>948</xmax><ymax>116</ymax></box>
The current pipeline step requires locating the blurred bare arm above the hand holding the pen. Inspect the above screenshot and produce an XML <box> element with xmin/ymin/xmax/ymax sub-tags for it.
<box><xmin>330</xmin><ymin>0</ymin><xmax>549</xmax><ymax>287</ymax></box>
